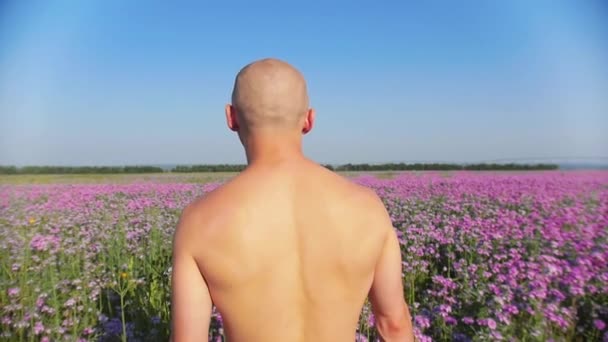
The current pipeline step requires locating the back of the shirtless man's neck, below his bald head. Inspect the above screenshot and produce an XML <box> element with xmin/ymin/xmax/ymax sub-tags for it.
<box><xmin>245</xmin><ymin>134</ymin><xmax>305</xmax><ymax>166</ymax></box>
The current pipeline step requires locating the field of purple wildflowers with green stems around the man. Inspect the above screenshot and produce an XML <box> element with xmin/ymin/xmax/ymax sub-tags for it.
<box><xmin>0</xmin><ymin>171</ymin><xmax>608</xmax><ymax>341</ymax></box>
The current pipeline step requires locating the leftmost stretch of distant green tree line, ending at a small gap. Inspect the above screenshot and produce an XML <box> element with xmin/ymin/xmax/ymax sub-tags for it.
<box><xmin>0</xmin><ymin>165</ymin><xmax>163</xmax><ymax>175</ymax></box>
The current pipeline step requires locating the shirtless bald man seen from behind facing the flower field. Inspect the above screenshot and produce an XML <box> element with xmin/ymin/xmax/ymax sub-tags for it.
<box><xmin>171</xmin><ymin>59</ymin><xmax>414</xmax><ymax>342</ymax></box>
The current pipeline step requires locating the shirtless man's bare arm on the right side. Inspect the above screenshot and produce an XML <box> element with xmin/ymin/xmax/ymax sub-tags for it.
<box><xmin>369</xmin><ymin>200</ymin><xmax>414</xmax><ymax>342</ymax></box>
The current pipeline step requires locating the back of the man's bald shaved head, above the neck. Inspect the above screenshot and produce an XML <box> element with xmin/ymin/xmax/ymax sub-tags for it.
<box><xmin>232</xmin><ymin>58</ymin><xmax>308</xmax><ymax>130</ymax></box>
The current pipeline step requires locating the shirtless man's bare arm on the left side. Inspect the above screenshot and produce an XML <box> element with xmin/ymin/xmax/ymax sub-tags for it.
<box><xmin>171</xmin><ymin>208</ymin><xmax>212</xmax><ymax>342</ymax></box>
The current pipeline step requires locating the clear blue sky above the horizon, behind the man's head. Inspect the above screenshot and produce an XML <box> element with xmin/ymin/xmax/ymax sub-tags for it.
<box><xmin>0</xmin><ymin>0</ymin><xmax>608</xmax><ymax>165</ymax></box>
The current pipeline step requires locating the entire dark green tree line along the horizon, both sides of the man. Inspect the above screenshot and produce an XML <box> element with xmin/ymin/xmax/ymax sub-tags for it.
<box><xmin>0</xmin><ymin>163</ymin><xmax>559</xmax><ymax>175</ymax></box>
